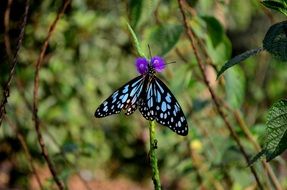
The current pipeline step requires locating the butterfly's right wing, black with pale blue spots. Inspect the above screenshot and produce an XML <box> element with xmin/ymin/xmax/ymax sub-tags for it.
<box><xmin>139</xmin><ymin>76</ymin><xmax>188</xmax><ymax>136</ymax></box>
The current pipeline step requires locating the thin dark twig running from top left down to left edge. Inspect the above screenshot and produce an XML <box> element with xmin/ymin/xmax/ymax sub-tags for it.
<box><xmin>0</xmin><ymin>0</ymin><xmax>29</xmax><ymax>127</ymax></box>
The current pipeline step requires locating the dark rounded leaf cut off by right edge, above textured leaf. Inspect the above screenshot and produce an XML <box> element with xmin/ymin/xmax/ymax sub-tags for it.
<box><xmin>263</xmin><ymin>21</ymin><xmax>287</xmax><ymax>61</ymax></box>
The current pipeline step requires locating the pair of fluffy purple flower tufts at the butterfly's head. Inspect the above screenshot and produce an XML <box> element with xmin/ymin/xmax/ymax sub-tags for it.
<box><xmin>136</xmin><ymin>56</ymin><xmax>166</xmax><ymax>75</ymax></box>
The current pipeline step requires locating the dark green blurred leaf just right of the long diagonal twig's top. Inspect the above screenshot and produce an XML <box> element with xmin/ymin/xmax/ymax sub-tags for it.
<box><xmin>201</xmin><ymin>16</ymin><xmax>224</xmax><ymax>47</ymax></box>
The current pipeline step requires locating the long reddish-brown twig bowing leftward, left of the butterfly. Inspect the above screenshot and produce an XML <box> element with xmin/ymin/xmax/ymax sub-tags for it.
<box><xmin>33</xmin><ymin>0</ymin><xmax>70</xmax><ymax>189</ymax></box>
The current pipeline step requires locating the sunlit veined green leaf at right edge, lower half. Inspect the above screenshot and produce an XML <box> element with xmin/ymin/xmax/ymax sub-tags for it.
<box><xmin>264</xmin><ymin>99</ymin><xmax>287</xmax><ymax>161</ymax></box>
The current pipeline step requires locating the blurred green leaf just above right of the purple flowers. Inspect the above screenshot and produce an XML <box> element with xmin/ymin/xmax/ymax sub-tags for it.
<box><xmin>147</xmin><ymin>24</ymin><xmax>183</xmax><ymax>56</ymax></box>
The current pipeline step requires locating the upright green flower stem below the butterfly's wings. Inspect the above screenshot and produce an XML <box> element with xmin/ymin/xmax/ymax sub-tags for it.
<box><xmin>149</xmin><ymin>121</ymin><xmax>161</xmax><ymax>190</ymax></box>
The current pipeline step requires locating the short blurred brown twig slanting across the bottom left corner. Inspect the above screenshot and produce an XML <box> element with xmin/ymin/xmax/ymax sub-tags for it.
<box><xmin>5</xmin><ymin>116</ymin><xmax>44</xmax><ymax>189</ymax></box>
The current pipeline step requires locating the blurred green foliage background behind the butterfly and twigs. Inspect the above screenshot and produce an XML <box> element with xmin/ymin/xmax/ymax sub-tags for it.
<box><xmin>0</xmin><ymin>0</ymin><xmax>287</xmax><ymax>189</ymax></box>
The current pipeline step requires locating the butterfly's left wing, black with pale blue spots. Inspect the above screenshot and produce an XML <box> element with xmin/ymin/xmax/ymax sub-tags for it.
<box><xmin>95</xmin><ymin>75</ymin><xmax>145</xmax><ymax>118</ymax></box>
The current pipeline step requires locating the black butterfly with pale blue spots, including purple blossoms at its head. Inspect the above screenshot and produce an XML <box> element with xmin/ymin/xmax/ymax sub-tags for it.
<box><xmin>95</xmin><ymin>56</ymin><xmax>188</xmax><ymax>136</ymax></box>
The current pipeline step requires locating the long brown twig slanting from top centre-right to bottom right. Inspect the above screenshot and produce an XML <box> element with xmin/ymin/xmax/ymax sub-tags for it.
<box><xmin>178</xmin><ymin>0</ymin><xmax>263</xmax><ymax>189</ymax></box>
